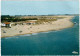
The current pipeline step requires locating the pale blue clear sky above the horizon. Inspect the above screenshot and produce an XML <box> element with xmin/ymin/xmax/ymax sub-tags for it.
<box><xmin>1</xmin><ymin>1</ymin><xmax>79</xmax><ymax>15</ymax></box>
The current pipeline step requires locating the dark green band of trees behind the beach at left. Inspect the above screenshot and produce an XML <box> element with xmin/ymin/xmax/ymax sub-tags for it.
<box><xmin>1</xmin><ymin>15</ymin><xmax>37</xmax><ymax>22</ymax></box>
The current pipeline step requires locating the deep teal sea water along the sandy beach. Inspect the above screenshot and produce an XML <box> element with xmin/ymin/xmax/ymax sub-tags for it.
<box><xmin>1</xmin><ymin>16</ymin><xmax>79</xmax><ymax>55</ymax></box>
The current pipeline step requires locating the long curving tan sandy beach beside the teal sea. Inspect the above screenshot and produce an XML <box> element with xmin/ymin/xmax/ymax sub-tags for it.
<box><xmin>1</xmin><ymin>16</ymin><xmax>74</xmax><ymax>38</ymax></box>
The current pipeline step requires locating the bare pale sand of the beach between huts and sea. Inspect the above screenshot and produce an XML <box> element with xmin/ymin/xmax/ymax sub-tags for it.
<box><xmin>1</xmin><ymin>16</ymin><xmax>74</xmax><ymax>38</ymax></box>
